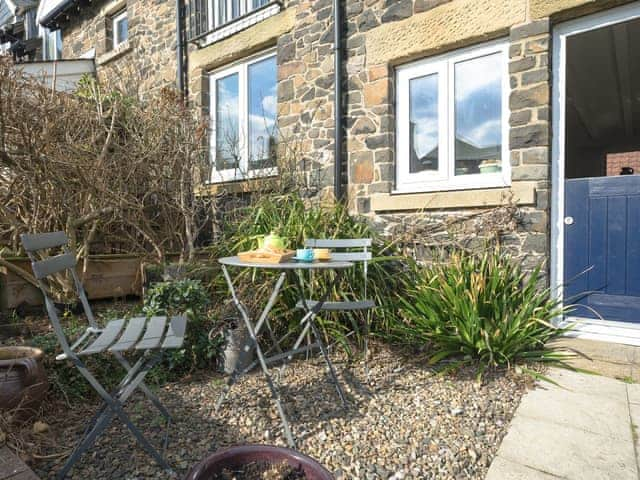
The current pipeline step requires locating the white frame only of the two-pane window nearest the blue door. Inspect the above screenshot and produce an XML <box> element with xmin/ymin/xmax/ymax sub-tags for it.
<box><xmin>393</xmin><ymin>39</ymin><xmax>511</xmax><ymax>193</ymax></box>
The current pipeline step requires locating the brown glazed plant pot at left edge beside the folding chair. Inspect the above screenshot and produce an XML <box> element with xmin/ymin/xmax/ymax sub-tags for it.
<box><xmin>0</xmin><ymin>347</ymin><xmax>48</xmax><ymax>421</ymax></box>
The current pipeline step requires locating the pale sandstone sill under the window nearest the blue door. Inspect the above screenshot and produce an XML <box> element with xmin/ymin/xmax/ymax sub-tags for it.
<box><xmin>371</xmin><ymin>182</ymin><xmax>536</xmax><ymax>212</ymax></box>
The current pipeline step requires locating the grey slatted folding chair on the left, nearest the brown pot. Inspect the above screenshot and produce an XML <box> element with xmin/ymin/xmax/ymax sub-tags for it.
<box><xmin>20</xmin><ymin>232</ymin><xmax>187</xmax><ymax>479</ymax></box>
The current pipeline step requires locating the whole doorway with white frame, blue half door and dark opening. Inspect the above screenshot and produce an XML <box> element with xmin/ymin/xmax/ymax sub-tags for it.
<box><xmin>552</xmin><ymin>2</ymin><xmax>640</xmax><ymax>342</ymax></box>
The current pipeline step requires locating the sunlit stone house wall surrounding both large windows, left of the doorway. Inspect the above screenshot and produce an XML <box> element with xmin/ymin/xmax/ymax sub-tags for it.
<box><xmin>190</xmin><ymin>0</ymin><xmax>640</xmax><ymax>276</ymax></box>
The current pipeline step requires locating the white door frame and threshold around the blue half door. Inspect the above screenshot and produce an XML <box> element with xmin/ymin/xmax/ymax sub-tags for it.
<box><xmin>550</xmin><ymin>1</ymin><xmax>640</xmax><ymax>345</ymax></box>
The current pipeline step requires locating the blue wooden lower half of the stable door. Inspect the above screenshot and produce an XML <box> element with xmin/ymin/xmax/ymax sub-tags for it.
<box><xmin>564</xmin><ymin>175</ymin><xmax>640</xmax><ymax>323</ymax></box>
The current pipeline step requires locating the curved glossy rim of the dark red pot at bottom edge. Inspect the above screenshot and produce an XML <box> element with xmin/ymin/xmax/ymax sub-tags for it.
<box><xmin>185</xmin><ymin>445</ymin><xmax>334</xmax><ymax>480</ymax></box>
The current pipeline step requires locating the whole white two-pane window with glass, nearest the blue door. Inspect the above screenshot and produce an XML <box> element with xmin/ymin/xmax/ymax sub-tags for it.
<box><xmin>396</xmin><ymin>40</ymin><xmax>511</xmax><ymax>192</ymax></box>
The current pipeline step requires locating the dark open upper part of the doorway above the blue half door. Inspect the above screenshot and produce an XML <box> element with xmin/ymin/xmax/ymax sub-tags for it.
<box><xmin>565</xmin><ymin>18</ymin><xmax>640</xmax><ymax>179</ymax></box>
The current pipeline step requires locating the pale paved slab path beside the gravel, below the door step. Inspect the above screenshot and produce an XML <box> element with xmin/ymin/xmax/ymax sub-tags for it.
<box><xmin>487</xmin><ymin>368</ymin><xmax>640</xmax><ymax>480</ymax></box>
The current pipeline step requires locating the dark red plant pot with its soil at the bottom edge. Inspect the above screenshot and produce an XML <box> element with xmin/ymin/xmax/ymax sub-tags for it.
<box><xmin>185</xmin><ymin>445</ymin><xmax>334</xmax><ymax>480</ymax></box>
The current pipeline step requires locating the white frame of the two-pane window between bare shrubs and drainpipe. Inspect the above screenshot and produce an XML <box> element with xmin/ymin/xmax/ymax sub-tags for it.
<box><xmin>209</xmin><ymin>49</ymin><xmax>278</xmax><ymax>183</ymax></box>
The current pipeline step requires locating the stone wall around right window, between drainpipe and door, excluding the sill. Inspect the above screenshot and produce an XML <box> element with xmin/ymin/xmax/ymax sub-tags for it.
<box><xmin>345</xmin><ymin>0</ymin><xmax>550</xmax><ymax>268</ymax></box>
